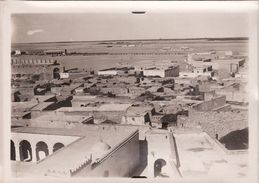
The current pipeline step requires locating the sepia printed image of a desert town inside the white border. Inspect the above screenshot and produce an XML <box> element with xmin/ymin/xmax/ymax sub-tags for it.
<box><xmin>1</xmin><ymin>1</ymin><xmax>256</xmax><ymax>181</ymax></box>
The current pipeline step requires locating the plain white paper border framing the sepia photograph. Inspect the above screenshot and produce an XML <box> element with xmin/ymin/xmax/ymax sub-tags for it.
<box><xmin>0</xmin><ymin>1</ymin><xmax>259</xmax><ymax>183</ymax></box>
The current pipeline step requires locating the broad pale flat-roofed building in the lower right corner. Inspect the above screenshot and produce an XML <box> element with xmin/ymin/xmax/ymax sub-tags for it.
<box><xmin>174</xmin><ymin>132</ymin><xmax>248</xmax><ymax>179</ymax></box>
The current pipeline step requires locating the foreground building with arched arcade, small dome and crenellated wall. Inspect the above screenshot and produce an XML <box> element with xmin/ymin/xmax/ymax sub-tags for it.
<box><xmin>11</xmin><ymin>125</ymin><xmax>183</xmax><ymax>178</ymax></box>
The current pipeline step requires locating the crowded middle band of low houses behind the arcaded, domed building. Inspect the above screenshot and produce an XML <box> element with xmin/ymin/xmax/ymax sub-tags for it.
<box><xmin>12</xmin><ymin>52</ymin><xmax>247</xmax><ymax>134</ymax></box>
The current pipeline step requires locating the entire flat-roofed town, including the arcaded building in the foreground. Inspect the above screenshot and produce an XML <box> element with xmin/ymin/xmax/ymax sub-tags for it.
<box><xmin>10</xmin><ymin>48</ymin><xmax>248</xmax><ymax>178</ymax></box>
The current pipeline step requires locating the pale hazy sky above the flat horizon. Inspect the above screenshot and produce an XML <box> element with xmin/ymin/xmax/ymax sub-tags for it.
<box><xmin>12</xmin><ymin>12</ymin><xmax>248</xmax><ymax>43</ymax></box>
